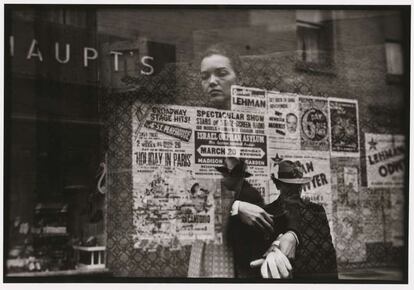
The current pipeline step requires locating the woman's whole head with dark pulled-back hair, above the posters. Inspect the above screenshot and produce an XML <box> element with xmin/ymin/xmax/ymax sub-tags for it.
<box><xmin>200</xmin><ymin>44</ymin><xmax>241</xmax><ymax>110</ymax></box>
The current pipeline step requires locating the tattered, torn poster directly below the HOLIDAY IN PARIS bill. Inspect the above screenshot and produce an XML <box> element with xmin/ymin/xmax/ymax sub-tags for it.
<box><xmin>133</xmin><ymin>167</ymin><xmax>220</xmax><ymax>251</ymax></box>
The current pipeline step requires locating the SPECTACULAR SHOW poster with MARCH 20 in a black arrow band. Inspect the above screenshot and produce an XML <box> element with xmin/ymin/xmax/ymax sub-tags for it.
<box><xmin>193</xmin><ymin>108</ymin><xmax>268</xmax><ymax>178</ymax></box>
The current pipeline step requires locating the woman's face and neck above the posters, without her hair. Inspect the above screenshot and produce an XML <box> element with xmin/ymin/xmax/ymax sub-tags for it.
<box><xmin>200</xmin><ymin>54</ymin><xmax>237</xmax><ymax>109</ymax></box>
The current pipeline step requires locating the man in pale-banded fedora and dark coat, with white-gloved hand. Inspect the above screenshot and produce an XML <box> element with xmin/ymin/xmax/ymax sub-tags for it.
<box><xmin>253</xmin><ymin>160</ymin><xmax>338</xmax><ymax>281</ymax></box>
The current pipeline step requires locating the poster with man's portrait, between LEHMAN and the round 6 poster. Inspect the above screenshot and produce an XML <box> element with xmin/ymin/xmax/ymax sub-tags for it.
<box><xmin>266</xmin><ymin>91</ymin><xmax>300</xmax><ymax>149</ymax></box>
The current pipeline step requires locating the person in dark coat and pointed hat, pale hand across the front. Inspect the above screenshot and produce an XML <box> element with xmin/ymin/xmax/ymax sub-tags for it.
<box><xmin>216</xmin><ymin>157</ymin><xmax>299</xmax><ymax>278</ymax></box>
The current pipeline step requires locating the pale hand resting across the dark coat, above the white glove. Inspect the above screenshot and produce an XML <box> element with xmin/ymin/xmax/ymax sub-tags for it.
<box><xmin>238</xmin><ymin>201</ymin><xmax>274</xmax><ymax>235</ymax></box>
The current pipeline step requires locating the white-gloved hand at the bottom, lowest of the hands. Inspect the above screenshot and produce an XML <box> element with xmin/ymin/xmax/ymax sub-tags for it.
<box><xmin>250</xmin><ymin>242</ymin><xmax>292</xmax><ymax>279</ymax></box>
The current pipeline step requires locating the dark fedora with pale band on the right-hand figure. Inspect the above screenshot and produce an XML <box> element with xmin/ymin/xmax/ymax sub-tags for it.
<box><xmin>274</xmin><ymin>160</ymin><xmax>312</xmax><ymax>184</ymax></box>
